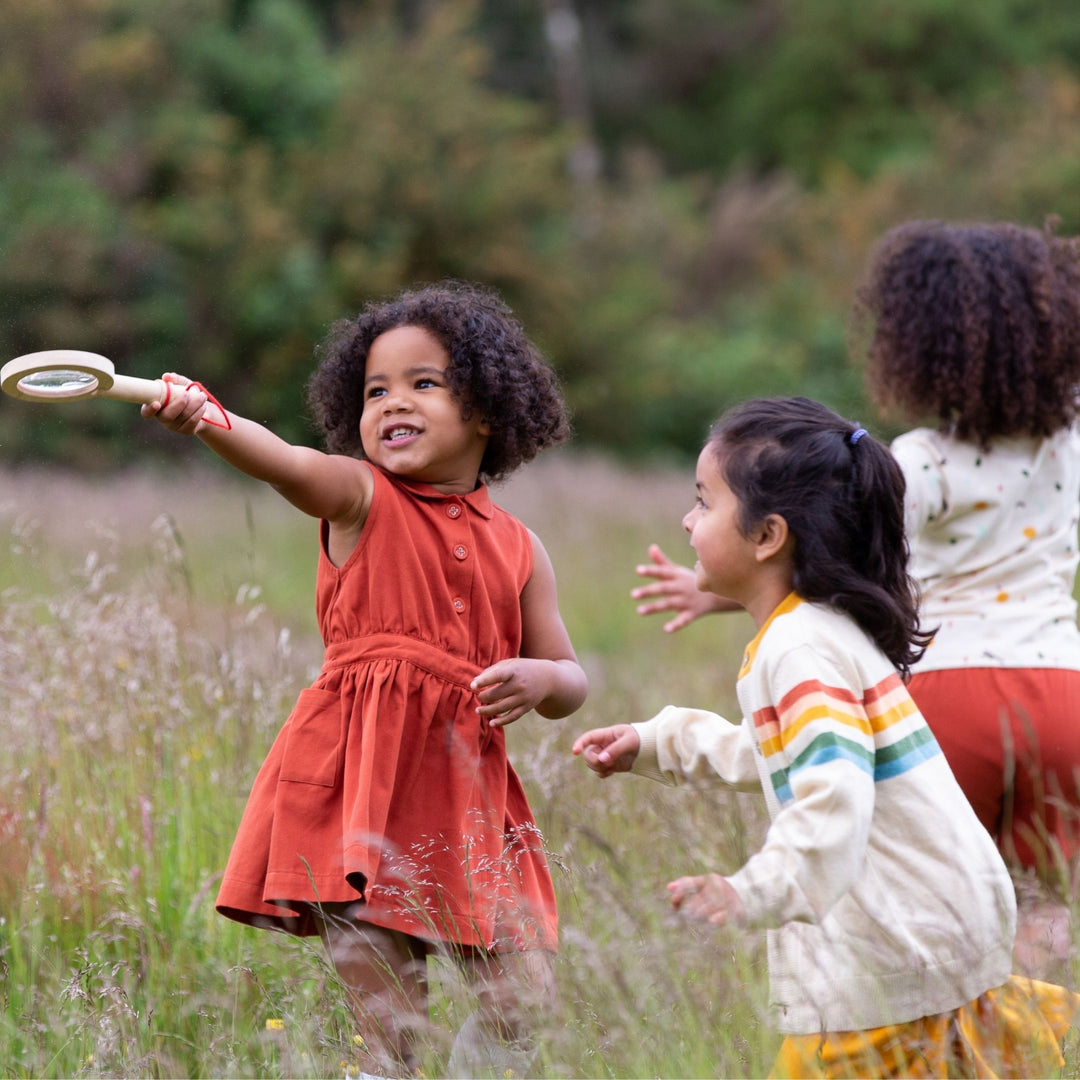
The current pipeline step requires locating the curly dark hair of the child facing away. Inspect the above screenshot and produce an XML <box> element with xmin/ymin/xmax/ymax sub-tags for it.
<box><xmin>853</xmin><ymin>221</ymin><xmax>1080</xmax><ymax>448</ymax></box>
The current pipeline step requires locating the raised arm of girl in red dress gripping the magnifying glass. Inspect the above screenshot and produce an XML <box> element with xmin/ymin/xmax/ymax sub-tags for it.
<box><xmin>143</xmin><ymin>373</ymin><xmax>374</xmax><ymax>523</ymax></box>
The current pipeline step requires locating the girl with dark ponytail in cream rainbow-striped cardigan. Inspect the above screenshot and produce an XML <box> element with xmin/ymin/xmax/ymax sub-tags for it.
<box><xmin>573</xmin><ymin>397</ymin><xmax>1080</xmax><ymax>1077</ymax></box>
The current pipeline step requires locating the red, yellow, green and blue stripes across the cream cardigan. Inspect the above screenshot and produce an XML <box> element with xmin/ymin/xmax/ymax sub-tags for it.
<box><xmin>754</xmin><ymin>672</ymin><xmax>941</xmax><ymax>802</ymax></box>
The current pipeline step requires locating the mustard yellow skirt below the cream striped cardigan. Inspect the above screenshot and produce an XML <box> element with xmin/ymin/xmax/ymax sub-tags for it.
<box><xmin>771</xmin><ymin>975</ymin><xmax>1080</xmax><ymax>1080</ymax></box>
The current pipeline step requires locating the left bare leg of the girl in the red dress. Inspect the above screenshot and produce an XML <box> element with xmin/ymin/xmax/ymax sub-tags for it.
<box><xmin>320</xmin><ymin>904</ymin><xmax>428</xmax><ymax>1074</ymax></box>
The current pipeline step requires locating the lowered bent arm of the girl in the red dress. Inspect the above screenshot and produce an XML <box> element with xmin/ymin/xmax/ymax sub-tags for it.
<box><xmin>472</xmin><ymin>531</ymin><xmax>589</xmax><ymax>727</ymax></box>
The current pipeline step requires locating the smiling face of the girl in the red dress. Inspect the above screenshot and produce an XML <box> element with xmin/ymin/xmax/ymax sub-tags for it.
<box><xmin>360</xmin><ymin>326</ymin><xmax>490</xmax><ymax>494</ymax></box>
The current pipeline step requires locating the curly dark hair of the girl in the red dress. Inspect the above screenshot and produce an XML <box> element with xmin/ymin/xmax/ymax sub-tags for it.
<box><xmin>307</xmin><ymin>281</ymin><xmax>570</xmax><ymax>482</ymax></box>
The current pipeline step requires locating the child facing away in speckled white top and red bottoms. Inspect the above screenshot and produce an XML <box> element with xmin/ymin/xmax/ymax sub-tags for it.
<box><xmin>855</xmin><ymin>221</ymin><xmax>1080</xmax><ymax>974</ymax></box>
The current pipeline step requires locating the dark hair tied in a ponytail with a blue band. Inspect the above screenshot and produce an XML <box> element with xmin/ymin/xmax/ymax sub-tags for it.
<box><xmin>706</xmin><ymin>397</ymin><xmax>932</xmax><ymax>678</ymax></box>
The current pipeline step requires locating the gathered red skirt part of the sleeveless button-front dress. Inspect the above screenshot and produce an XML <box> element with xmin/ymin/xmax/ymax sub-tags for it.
<box><xmin>217</xmin><ymin>634</ymin><xmax>557</xmax><ymax>951</ymax></box>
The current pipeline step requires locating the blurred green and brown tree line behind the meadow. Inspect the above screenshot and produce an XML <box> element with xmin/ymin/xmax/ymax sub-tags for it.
<box><xmin>0</xmin><ymin>0</ymin><xmax>1080</xmax><ymax>467</ymax></box>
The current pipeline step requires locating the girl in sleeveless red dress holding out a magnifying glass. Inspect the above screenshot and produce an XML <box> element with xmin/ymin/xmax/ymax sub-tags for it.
<box><xmin>144</xmin><ymin>283</ymin><xmax>586</xmax><ymax>1076</ymax></box>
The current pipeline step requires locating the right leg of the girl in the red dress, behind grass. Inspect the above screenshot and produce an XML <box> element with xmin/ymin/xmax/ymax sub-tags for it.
<box><xmin>447</xmin><ymin>949</ymin><xmax>555</xmax><ymax>1077</ymax></box>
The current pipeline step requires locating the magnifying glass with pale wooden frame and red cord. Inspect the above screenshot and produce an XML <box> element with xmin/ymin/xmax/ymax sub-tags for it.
<box><xmin>0</xmin><ymin>349</ymin><xmax>229</xmax><ymax>428</ymax></box>
